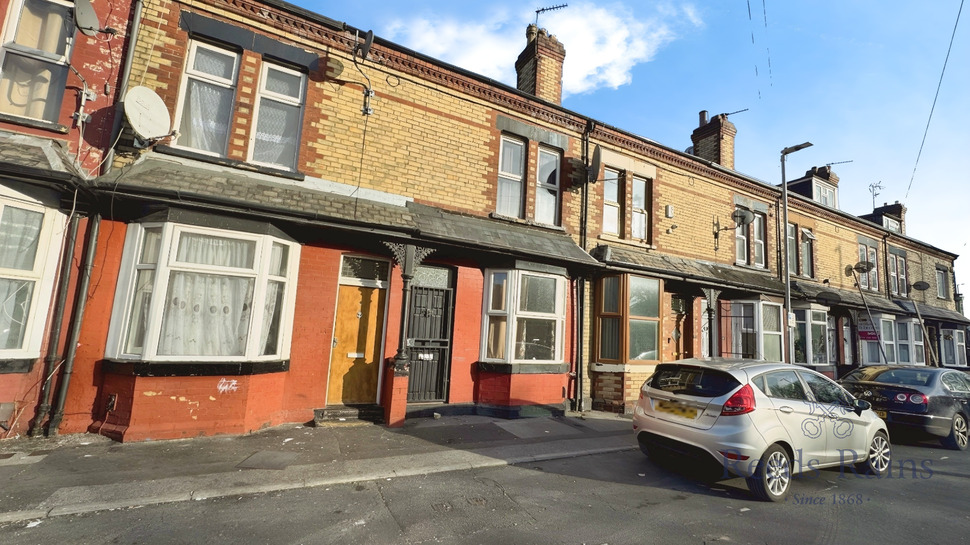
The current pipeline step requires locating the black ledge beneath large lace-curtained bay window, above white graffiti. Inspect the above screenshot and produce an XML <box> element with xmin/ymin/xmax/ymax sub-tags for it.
<box><xmin>102</xmin><ymin>360</ymin><xmax>290</xmax><ymax>377</ymax></box>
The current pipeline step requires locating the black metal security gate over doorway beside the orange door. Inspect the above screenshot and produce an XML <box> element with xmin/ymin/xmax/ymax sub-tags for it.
<box><xmin>408</xmin><ymin>271</ymin><xmax>454</xmax><ymax>402</ymax></box>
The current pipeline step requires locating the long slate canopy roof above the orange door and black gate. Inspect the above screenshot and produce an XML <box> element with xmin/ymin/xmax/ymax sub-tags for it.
<box><xmin>96</xmin><ymin>154</ymin><xmax>599</xmax><ymax>266</ymax></box>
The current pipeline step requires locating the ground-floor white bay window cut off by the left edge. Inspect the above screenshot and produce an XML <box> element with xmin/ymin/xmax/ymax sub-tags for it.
<box><xmin>0</xmin><ymin>193</ymin><xmax>63</xmax><ymax>360</ymax></box>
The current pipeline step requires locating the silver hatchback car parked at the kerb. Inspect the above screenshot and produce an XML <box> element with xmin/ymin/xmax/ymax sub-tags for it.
<box><xmin>633</xmin><ymin>358</ymin><xmax>892</xmax><ymax>501</ymax></box>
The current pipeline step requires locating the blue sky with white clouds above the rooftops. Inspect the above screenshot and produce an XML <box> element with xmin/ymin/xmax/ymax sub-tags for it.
<box><xmin>296</xmin><ymin>0</ymin><xmax>970</xmax><ymax>300</ymax></box>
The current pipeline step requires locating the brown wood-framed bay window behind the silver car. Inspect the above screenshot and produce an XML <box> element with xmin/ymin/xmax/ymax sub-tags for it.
<box><xmin>596</xmin><ymin>275</ymin><xmax>661</xmax><ymax>362</ymax></box>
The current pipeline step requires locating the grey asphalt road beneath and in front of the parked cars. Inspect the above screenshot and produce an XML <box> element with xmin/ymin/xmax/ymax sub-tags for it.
<box><xmin>0</xmin><ymin>438</ymin><xmax>970</xmax><ymax>545</ymax></box>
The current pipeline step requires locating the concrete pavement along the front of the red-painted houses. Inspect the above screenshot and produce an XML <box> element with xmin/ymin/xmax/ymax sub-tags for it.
<box><xmin>0</xmin><ymin>412</ymin><xmax>637</xmax><ymax>523</ymax></box>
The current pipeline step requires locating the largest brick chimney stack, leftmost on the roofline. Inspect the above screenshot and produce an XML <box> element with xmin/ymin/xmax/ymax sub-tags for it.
<box><xmin>515</xmin><ymin>25</ymin><xmax>566</xmax><ymax>105</ymax></box>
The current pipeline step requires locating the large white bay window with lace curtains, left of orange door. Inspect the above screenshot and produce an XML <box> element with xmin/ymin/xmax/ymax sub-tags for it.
<box><xmin>108</xmin><ymin>223</ymin><xmax>300</xmax><ymax>362</ymax></box>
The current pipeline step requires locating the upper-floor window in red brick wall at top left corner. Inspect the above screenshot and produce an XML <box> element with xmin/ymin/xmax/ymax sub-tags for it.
<box><xmin>0</xmin><ymin>0</ymin><xmax>75</xmax><ymax>123</ymax></box>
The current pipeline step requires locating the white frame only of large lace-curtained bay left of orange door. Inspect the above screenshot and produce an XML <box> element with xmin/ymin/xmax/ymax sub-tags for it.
<box><xmin>105</xmin><ymin>222</ymin><xmax>301</xmax><ymax>362</ymax></box>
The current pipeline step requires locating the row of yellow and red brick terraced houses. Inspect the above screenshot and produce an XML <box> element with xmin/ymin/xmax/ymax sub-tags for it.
<box><xmin>0</xmin><ymin>0</ymin><xmax>970</xmax><ymax>441</ymax></box>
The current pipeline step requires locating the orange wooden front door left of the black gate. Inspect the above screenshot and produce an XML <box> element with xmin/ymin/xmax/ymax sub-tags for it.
<box><xmin>327</xmin><ymin>285</ymin><xmax>386</xmax><ymax>405</ymax></box>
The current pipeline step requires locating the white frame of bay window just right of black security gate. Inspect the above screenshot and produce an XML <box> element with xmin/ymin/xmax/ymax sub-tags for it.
<box><xmin>480</xmin><ymin>269</ymin><xmax>568</xmax><ymax>364</ymax></box>
